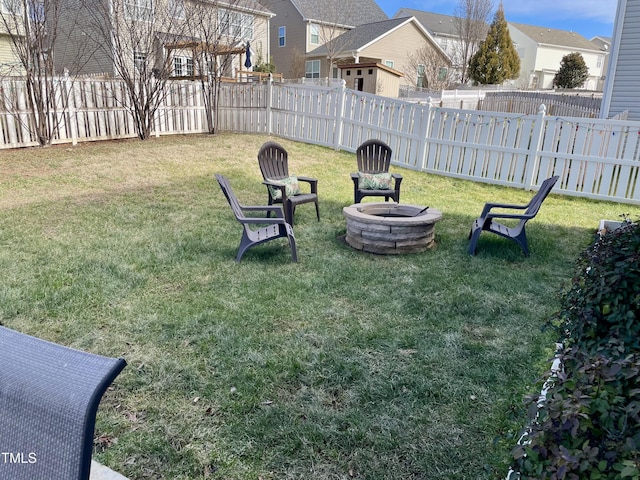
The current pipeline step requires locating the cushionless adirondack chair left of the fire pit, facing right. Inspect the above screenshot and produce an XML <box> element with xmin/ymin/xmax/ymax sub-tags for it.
<box><xmin>216</xmin><ymin>174</ymin><xmax>298</xmax><ymax>262</ymax></box>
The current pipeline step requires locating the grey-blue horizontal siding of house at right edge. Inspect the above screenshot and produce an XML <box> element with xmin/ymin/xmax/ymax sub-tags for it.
<box><xmin>600</xmin><ymin>0</ymin><xmax>640</xmax><ymax>120</ymax></box>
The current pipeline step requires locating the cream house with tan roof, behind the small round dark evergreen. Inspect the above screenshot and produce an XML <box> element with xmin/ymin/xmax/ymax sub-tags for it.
<box><xmin>508</xmin><ymin>22</ymin><xmax>607</xmax><ymax>90</ymax></box>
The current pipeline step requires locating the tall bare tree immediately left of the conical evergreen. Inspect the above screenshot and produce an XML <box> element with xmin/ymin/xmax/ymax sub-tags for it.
<box><xmin>453</xmin><ymin>0</ymin><xmax>493</xmax><ymax>83</ymax></box>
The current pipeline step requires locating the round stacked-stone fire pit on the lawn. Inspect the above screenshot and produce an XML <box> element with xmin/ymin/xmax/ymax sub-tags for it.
<box><xmin>342</xmin><ymin>202</ymin><xmax>442</xmax><ymax>255</ymax></box>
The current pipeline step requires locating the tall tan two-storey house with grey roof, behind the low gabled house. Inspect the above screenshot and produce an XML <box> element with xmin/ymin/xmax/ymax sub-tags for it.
<box><xmin>262</xmin><ymin>0</ymin><xmax>389</xmax><ymax>78</ymax></box>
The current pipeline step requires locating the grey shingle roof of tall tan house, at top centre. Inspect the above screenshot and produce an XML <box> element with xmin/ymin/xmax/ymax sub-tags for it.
<box><xmin>291</xmin><ymin>0</ymin><xmax>389</xmax><ymax>27</ymax></box>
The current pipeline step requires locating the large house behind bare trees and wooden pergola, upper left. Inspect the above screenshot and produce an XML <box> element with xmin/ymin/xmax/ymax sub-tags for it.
<box><xmin>56</xmin><ymin>0</ymin><xmax>273</xmax><ymax>78</ymax></box>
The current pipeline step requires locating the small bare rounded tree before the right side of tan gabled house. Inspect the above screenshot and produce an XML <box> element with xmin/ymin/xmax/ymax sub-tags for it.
<box><xmin>403</xmin><ymin>44</ymin><xmax>454</xmax><ymax>90</ymax></box>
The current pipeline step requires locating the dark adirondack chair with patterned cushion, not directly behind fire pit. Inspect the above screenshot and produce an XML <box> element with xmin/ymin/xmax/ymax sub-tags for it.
<box><xmin>258</xmin><ymin>142</ymin><xmax>320</xmax><ymax>226</ymax></box>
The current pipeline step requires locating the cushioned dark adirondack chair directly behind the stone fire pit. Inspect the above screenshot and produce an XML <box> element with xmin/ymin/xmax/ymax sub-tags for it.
<box><xmin>351</xmin><ymin>140</ymin><xmax>402</xmax><ymax>203</ymax></box>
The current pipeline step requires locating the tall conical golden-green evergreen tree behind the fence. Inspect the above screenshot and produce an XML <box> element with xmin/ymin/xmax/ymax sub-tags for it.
<box><xmin>469</xmin><ymin>2</ymin><xmax>520</xmax><ymax>85</ymax></box>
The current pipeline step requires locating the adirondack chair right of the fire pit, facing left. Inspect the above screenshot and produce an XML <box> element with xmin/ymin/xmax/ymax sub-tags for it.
<box><xmin>469</xmin><ymin>175</ymin><xmax>558</xmax><ymax>256</ymax></box>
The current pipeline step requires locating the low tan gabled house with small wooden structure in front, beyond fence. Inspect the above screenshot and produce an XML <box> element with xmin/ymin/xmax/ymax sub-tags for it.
<box><xmin>307</xmin><ymin>17</ymin><xmax>451</xmax><ymax>97</ymax></box>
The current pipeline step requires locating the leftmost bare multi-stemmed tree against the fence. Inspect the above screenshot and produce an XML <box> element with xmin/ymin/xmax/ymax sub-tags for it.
<box><xmin>0</xmin><ymin>0</ymin><xmax>65</xmax><ymax>146</ymax></box>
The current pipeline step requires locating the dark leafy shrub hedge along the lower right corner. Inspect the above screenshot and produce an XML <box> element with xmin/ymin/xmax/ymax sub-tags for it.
<box><xmin>512</xmin><ymin>222</ymin><xmax>640</xmax><ymax>480</ymax></box>
